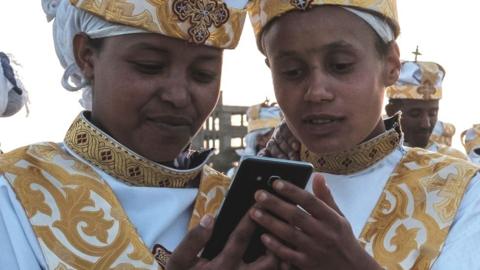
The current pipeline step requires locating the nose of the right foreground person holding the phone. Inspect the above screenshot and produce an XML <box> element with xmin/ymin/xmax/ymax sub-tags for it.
<box><xmin>304</xmin><ymin>69</ymin><xmax>335</xmax><ymax>103</ymax></box>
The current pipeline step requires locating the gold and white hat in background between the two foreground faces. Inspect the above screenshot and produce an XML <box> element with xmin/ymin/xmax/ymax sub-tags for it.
<box><xmin>247</xmin><ymin>103</ymin><xmax>283</xmax><ymax>133</ymax></box>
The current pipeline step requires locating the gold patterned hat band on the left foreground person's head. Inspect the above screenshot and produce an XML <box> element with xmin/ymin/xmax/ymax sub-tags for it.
<box><xmin>70</xmin><ymin>0</ymin><xmax>246</xmax><ymax>49</ymax></box>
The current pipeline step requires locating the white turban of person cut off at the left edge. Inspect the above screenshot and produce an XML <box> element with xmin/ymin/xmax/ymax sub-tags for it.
<box><xmin>0</xmin><ymin>52</ymin><xmax>28</xmax><ymax>117</ymax></box>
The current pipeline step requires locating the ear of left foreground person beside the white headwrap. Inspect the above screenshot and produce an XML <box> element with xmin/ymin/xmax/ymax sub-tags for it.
<box><xmin>73</xmin><ymin>33</ymin><xmax>95</xmax><ymax>81</ymax></box>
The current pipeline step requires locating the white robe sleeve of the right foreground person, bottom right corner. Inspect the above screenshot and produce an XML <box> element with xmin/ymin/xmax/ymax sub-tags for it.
<box><xmin>432</xmin><ymin>173</ymin><xmax>480</xmax><ymax>270</ymax></box>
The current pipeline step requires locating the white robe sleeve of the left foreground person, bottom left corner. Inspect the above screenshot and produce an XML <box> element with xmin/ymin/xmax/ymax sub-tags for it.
<box><xmin>0</xmin><ymin>176</ymin><xmax>46</xmax><ymax>270</ymax></box>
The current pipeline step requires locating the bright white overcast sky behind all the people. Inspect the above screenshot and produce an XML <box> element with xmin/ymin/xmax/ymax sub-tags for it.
<box><xmin>0</xmin><ymin>0</ymin><xmax>480</xmax><ymax>151</ymax></box>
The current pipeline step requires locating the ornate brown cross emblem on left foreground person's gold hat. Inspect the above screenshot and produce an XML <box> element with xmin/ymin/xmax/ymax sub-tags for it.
<box><xmin>173</xmin><ymin>0</ymin><xmax>230</xmax><ymax>44</ymax></box>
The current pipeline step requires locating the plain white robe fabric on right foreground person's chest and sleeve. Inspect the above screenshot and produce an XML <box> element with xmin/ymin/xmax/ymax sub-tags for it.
<box><xmin>307</xmin><ymin>147</ymin><xmax>480</xmax><ymax>270</ymax></box>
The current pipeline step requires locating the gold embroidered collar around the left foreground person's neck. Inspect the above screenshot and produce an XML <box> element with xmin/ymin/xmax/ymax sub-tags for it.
<box><xmin>64</xmin><ymin>112</ymin><xmax>208</xmax><ymax>188</ymax></box>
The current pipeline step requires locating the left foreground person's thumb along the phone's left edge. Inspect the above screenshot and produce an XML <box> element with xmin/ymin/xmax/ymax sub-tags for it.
<box><xmin>167</xmin><ymin>215</ymin><xmax>214</xmax><ymax>270</ymax></box>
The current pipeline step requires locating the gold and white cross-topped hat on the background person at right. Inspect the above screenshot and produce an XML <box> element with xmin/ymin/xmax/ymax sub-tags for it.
<box><xmin>387</xmin><ymin>61</ymin><xmax>445</xmax><ymax>100</ymax></box>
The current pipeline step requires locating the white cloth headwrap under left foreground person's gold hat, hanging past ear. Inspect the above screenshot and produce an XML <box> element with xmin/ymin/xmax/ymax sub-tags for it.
<box><xmin>42</xmin><ymin>0</ymin><xmax>146</xmax><ymax>110</ymax></box>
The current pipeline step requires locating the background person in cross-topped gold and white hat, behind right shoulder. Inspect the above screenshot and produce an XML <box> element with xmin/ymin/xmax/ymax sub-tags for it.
<box><xmin>385</xmin><ymin>61</ymin><xmax>468</xmax><ymax>160</ymax></box>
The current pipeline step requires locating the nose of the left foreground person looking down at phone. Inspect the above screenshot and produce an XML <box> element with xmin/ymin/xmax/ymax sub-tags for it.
<box><xmin>159</xmin><ymin>72</ymin><xmax>191</xmax><ymax>108</ymax></box>
